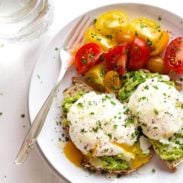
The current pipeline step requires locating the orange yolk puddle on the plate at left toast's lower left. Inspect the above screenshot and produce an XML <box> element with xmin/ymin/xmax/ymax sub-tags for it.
<box><xmin>64</xmin><ymin>141</ymin><xmax>84</xmax><ymax>167</ymax></box>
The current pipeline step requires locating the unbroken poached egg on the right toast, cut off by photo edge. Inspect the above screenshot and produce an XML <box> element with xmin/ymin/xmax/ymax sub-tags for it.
<box><xmin>128</xmin><ymin>77</ymin><xmax>183</xmax><ymax>141</ymax></box>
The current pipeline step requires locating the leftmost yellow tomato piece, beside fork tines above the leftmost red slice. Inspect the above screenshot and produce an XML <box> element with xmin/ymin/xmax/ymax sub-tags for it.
<box><xmin>85</xmin><ymin>27</ymin><xmax>117</xmax><ymax>51</ymax></box>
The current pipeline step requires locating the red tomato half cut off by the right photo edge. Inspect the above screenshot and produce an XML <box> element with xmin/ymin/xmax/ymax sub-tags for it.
<box><xmin>164</xmin><ymin>37</ymin><xmax>183</xmax><ymax>73</ymax></box>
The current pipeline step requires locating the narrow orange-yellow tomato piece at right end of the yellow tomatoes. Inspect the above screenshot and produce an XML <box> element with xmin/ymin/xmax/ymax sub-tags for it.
<box><xmin>151</xmin><ymin>31</ymin><xmax>169</xmax><ymax>56</ymax></box>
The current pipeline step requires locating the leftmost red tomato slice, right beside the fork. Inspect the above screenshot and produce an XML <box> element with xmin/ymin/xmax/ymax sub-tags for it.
<box><xmin>75</xmin><ymin>43</ymin><xmax>101</xmax><ymax>74</ymax></box>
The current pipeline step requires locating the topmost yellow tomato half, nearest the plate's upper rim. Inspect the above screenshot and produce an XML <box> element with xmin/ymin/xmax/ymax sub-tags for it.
<box><xmin>95</xmin><ymin>10</ymin><xmax>128</xmax><ymax>35</ymax></box>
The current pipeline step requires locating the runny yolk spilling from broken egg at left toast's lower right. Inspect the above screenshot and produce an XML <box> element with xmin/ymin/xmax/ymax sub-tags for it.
<box><xmin>116</xmin><ymin>144</ymin><xmax>151</xmax><ymax>169</ymax></box>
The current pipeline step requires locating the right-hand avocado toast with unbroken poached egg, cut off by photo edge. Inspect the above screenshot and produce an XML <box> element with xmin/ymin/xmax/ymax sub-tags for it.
<box><xmin>128</xmin><ymin>71</ymin><xmax>183</xmax><ymax>170</ymax></box>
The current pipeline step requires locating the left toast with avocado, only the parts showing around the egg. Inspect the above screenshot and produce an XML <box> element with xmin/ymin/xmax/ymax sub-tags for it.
<box><xmin>62</xmin><ymin>77</ymin><xmax>153</xmax><ymax>175</ymax></box>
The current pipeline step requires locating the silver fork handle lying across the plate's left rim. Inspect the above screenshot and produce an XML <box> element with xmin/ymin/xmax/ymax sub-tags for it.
<box><xmin>15</xmin><ymin>83</ymin><xmax>59</xmax><ymax>165</ymax></box>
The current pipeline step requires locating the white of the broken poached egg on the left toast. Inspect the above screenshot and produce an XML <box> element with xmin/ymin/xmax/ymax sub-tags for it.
<box><xmin>67</xmin><ymin>92</ymin><xmax>137</xmax><ymax>160</ymax></box>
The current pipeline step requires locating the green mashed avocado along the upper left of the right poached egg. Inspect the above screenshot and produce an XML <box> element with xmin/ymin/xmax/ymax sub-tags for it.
<box><xmin>118</xmin><ymin>70</ymin><xmax>173</xmax><ymax>102</ymax></box>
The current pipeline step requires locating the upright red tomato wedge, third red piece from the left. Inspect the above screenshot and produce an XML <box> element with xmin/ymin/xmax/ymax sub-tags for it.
<box><xmin>128</xmin><ymin>37</ymin><xmax>151</xmax><ymax>70</ymax></box>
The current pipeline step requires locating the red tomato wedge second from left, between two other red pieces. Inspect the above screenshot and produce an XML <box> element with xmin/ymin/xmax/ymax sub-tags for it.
<box><xmin>105</xmin><ymin>43</ymin><xmax>129</xmax><ymax>75</ymax></box>
